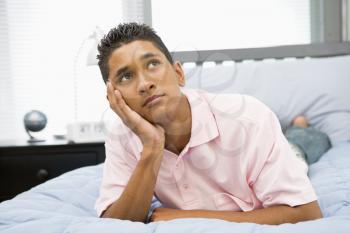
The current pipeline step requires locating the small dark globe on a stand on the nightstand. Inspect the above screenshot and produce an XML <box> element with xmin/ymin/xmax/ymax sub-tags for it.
<box><xmin>23</xmin><ymin>110</ymin><xmax>47</xmax><ymax>142</ymax></box>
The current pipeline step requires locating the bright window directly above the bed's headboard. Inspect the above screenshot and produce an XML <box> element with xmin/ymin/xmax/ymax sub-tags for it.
<box><xmin>152</xmin><ymin>0</ymin><xmax>311</xmax><ymax>51</ymax></box>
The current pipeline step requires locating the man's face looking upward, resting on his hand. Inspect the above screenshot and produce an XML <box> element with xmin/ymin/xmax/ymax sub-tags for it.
<box><xmin>108</xmin><ymin>40</ymin><xmax>185</xmax><ymax>123</ymax></box>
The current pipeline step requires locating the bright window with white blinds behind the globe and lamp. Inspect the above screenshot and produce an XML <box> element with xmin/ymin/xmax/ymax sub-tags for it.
<box><xmin>0</xmin><ymin>0</ymin><xmax>122</xmax><ymax>139</ymax></box>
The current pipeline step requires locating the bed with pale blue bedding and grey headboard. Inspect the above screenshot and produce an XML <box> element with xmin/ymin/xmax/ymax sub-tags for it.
<box><xmin>0</xmin><ymin>43</ymin><xmax>350</xmax><ymax>233</ymax></box>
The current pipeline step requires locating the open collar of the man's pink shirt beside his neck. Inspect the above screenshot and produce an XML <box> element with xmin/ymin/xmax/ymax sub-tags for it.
<box><xmin>181</xmin><ymin>88</ymin><xmax>219</xmax><ymax>147</ymax></box>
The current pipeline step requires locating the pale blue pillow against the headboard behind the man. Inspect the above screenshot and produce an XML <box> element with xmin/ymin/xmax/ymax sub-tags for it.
<box><xmin>185</xmin><ymin>56</ymin><xmax>350</xmax><ymax>146</ymax></box>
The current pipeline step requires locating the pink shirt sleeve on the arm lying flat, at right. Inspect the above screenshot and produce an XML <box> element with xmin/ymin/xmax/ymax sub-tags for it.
<box><xmin>252</xmin><ymin>103</ymin><xmax>317</xmax><ymax>207</ymax></box>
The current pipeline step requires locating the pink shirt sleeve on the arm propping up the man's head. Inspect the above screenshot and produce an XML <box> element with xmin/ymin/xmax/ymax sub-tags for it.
<box><xmin>95</xmin><ymin>133</ymin><xmax>137</xmax><ymax>216</ymax></box>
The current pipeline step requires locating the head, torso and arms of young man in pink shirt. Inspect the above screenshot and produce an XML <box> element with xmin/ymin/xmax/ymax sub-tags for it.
<box><xmin>96</xmin><ymin>23</ymin><xmax>322</xmax><ymax>224</ymax></box>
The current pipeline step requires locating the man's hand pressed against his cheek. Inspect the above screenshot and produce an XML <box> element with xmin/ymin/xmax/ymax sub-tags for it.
<box><xmin>107</xmin><ymin>82</ymin><xmax>165</xmax><ymax>150</ymax></box>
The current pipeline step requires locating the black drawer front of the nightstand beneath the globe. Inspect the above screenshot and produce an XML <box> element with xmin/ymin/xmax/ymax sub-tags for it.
<box><xmin>0</xmin><ymin>152</ymin><xmax>98</xmax><ymax>199</ymax></box>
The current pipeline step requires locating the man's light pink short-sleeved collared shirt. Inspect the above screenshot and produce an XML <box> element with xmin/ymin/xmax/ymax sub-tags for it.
<box><xmin>95</xmin><ymin>89</ymin><xmax>317</xmax><ymax>215</ymax></box>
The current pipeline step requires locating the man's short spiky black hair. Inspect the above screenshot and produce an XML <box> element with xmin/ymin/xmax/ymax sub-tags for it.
<box><xmin>97</xmin><ymin>23</ymin><xmax>174</xmax><ymax>82</ymax></box>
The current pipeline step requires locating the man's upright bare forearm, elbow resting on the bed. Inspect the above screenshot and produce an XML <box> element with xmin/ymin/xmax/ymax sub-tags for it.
<box><xmin>102</xmin><ymin>148</ymin><xmax>162</xmax><ymax>222</ymax></box>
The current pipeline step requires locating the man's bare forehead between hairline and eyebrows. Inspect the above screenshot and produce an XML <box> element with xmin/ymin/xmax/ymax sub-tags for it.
<box><xmin>108</xmin><ymin>40</ymin><xmax>163</xmax><ymax>68</ymax></box>
